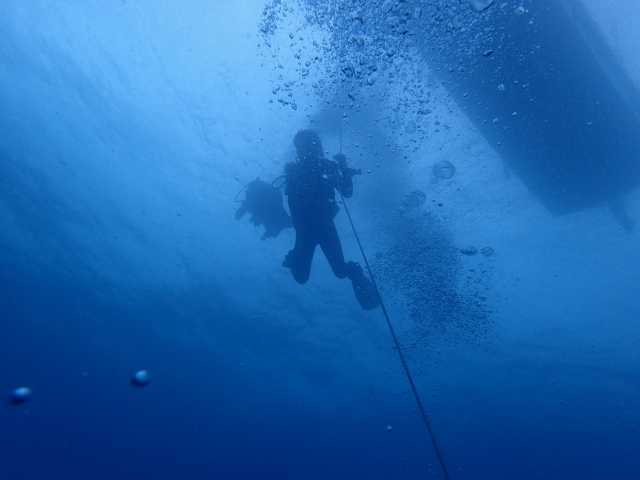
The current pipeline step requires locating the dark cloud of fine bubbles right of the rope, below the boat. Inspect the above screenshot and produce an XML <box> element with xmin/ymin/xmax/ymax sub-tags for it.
<box><xmin>374</xmin><ymin>197</ymin><xmax>491</xmax><ymax>340</ymax></box>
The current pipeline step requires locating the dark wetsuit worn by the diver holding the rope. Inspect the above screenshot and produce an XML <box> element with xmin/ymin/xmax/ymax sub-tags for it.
<box><xmin>284</xmin><ymin>158</ymin><xmax>358</xmax><ymax>283</ymax></box>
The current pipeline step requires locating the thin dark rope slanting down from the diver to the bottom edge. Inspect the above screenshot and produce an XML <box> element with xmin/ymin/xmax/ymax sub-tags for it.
<box><xmin>338</xmin><ymin>192</ymin><xmax>451</xmax><ymax>480</ymax></box>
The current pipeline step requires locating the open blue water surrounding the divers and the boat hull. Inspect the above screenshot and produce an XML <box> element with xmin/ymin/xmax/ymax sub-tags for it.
<box><xmin>0</xmin><ymin>0</ymin><xmax>640</xmax><ymax>480</ymax></box>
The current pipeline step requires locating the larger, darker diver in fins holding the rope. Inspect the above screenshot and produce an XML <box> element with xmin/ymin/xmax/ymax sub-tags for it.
<box><xmin>282</xmin><ymin>130</ymin><xmax>380</xmax><ymax>310</ymax></box>
